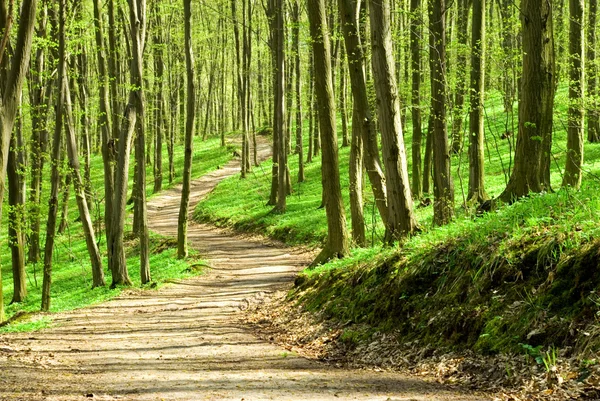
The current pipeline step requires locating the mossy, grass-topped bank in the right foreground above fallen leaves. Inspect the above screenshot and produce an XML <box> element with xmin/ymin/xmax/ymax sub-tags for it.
<box><xmin>289</xmin><ymin>183</ymin><xmax>600</xmax><ymax>353</ymax></box>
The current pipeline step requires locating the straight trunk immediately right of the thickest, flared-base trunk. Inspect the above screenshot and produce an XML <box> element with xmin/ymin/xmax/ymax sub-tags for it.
<box><xmin>562</xmin><ymin>0</ymin><xmax>583</xmax><ymax>189</ymax></box>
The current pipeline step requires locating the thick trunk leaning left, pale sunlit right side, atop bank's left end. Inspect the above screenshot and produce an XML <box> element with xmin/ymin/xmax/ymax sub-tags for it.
<box><xmin>369</xmin><ymin>0</ymin><xmax>417</xmax><ymax>238</ymax></box>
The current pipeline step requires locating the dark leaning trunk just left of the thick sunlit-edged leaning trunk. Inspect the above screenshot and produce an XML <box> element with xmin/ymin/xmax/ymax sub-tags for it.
<box><xmin>338</xmin><ymin>0</ymin><xmax>388</xmax><ymax>225</ymax></box>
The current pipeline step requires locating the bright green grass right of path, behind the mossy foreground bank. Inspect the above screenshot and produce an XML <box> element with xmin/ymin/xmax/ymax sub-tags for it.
<box><xmin>195</xmin><ymin>87</ymin><xmax>600</xmax><ymax>245</ymax></box>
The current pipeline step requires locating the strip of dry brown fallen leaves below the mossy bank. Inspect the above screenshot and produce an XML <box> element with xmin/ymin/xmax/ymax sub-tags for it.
<box><xmin>242</xmin><ymin>292</ymin><xmax>600</xmax><ymax>401</ymax></box>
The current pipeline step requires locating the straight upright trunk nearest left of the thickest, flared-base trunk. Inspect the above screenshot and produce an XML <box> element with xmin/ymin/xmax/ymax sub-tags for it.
<box><xmin>467</xmin><ymin>0</ymin><xmax>488</xmax><ymax>203</ymax></box>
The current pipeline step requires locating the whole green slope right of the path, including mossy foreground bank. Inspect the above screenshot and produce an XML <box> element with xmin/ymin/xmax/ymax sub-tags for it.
<box><xmin>196</xmin><ymin>88</ymin><xmax>600</xmax><ymax>352</ymax></box>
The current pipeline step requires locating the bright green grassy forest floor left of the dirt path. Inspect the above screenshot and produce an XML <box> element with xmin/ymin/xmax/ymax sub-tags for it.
<box><xmin>0</xmin><ymin>138</ymin><xmax>231</xmax><ymax>331</ymax></box>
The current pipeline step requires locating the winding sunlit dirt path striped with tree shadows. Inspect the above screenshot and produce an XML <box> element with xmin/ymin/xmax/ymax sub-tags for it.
<box><xmin>0</xmin><ymin>142</ymin><xmax>486</xmax><ymax>401</ymax></box>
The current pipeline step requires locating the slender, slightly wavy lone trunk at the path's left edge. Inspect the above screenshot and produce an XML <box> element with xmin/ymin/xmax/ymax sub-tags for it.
<box><xmin>177</xmin><ymin>0</ymin><xmax>196</xmax><ymax>258</ymax></box>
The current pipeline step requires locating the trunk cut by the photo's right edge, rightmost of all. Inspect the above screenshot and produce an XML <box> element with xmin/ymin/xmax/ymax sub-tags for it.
<box><xmin>586</xmin><ymin>0</ymin><xmax>600</xmax><ymax>143</ymax></box>
